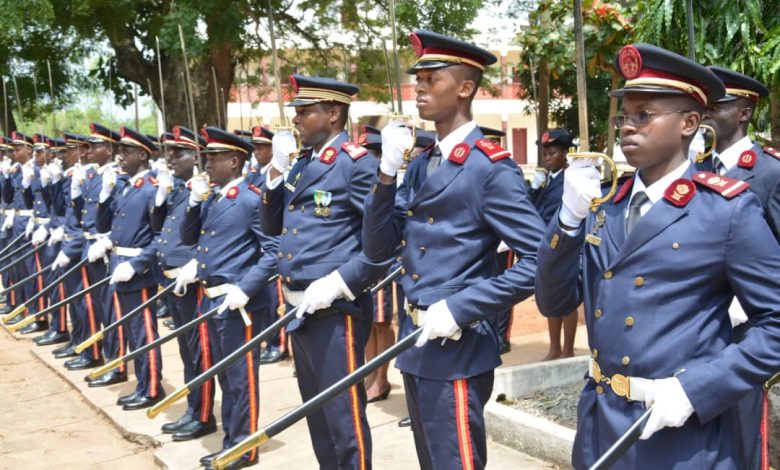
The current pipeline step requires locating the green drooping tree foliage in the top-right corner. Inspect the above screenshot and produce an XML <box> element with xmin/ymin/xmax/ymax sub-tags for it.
<box><xmin>636</xmin><ymin>0</ymin><xmax>780</xmax><ymax>147</ymax></box>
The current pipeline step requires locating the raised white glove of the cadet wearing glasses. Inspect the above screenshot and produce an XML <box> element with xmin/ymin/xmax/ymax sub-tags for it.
<box><xmin>559</xmin><ymin>159</ymin><xmax>601</xmax><ymax>227</ymax></box>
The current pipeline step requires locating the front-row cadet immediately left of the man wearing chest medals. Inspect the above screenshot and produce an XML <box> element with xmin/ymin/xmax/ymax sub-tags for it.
<box><xmin>176</xmin><ymin>127</ymin><xmax>277</xmax><ymax>469</ymax></box>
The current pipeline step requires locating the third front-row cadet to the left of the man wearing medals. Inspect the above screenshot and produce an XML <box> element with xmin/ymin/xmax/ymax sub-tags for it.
<box><xmin>95</xmin><ymin>127</ymin><xmax>165</xmax><ymax>410</ymax></box>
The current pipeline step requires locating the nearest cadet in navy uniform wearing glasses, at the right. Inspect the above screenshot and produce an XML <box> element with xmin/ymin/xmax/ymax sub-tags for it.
<box><xmin>536</xmin><ymin>44</ymin><xmax>780</xmax><ymax>469</ymax></box>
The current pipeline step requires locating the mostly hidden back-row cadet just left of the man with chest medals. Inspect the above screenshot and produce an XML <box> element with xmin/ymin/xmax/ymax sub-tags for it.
<box><xmin>241</xmin><ymin>126</ymin><xmax>289</xmax><ymax>365</ymax></box>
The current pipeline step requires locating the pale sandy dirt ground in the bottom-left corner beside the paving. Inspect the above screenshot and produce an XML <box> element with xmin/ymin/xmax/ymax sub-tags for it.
<box><xmin>0</xmin><ymin>329</ymin><xmax>155</xmax><ymax>470</ymax></box>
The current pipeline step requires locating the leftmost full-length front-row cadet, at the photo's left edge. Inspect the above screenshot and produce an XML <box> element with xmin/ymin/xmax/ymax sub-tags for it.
<box><xmin>0</xmin><ymin>131</ymin><xmax>33</xmax><ymax>325</ymax></box>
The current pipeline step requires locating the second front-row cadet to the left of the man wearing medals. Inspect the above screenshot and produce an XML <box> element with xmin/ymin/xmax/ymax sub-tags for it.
<box><xmin>151</xmin><ymin>126</ymin><xmax>217</xmax><ymax>441</ymax></box>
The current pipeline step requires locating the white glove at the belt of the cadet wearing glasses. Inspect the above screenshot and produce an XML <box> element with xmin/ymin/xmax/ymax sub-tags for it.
<box><xmin>639</xmin><ymin>377</ymin><xmax>694</xmax><ymax>439</ymax></box>
